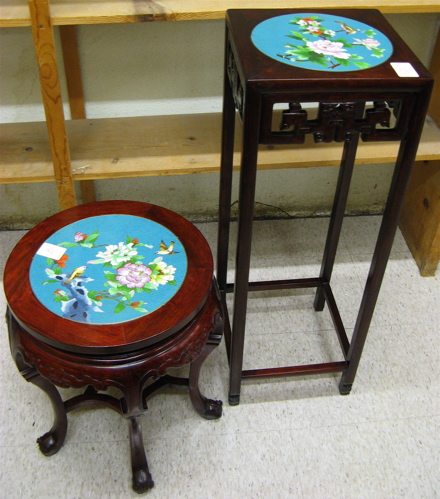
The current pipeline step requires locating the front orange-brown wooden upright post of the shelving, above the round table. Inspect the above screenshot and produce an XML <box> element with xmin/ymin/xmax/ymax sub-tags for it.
<box><xmin>29</xmin><ymin>0</ymin><xmax>76</xmax><ymax>209</ymax></box>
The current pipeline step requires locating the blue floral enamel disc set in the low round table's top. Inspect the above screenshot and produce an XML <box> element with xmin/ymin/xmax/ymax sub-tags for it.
<box><xmin>30</xmin><ymin>215</ymin><xmax>188</xmax><ymax>324</ymax></box>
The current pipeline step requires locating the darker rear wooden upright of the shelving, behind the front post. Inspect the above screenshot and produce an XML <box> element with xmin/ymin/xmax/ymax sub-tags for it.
<box><xmin>60</xmin><ymin>26</ymin><xmax>96</xmax><ymax>203</ymax></box>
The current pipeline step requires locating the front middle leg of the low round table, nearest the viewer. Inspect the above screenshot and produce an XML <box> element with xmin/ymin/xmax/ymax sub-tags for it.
<box><xmin>128</xmin><ymin>416</ymin><xmax>154</xmax><ymax>494</ymax></box>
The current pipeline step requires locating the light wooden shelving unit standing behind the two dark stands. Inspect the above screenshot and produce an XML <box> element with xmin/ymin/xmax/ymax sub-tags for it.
<box><xmin>0</xmin><ymin>0</ymin><xmax>440</xmax><ymax>274</ymax></box>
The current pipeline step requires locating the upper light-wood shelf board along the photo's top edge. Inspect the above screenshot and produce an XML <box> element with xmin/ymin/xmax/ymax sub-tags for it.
<box><xmin>0</xmin><ymin>0</ymin><xmax>440</xmax><ymax>27</ymax></box>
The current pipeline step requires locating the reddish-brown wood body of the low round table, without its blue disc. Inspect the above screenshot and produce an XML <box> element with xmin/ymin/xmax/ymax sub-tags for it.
<box><xmin>4</xmin><ymin>201</ymin><xmax>223</xmax><ymax>493</ymax></box>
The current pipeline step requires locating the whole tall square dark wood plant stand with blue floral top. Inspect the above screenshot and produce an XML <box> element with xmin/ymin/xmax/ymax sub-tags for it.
<box><xmin>217</xmin><ymin>9</ymin><xmax>433</xmax><ymax>405</ymax></box>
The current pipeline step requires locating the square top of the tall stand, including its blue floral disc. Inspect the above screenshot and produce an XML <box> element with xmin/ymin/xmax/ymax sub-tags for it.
<box><xmin>227</xmin><ymin>9</ymin><xmax>432</xmax><ymax>91</ymax></box>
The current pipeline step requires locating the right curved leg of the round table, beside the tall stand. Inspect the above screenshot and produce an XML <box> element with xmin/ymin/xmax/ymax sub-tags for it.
<box><xmin>189</xmin><ymin>317</ymin><xmax>223</xmax><ymax>419</ymax></box>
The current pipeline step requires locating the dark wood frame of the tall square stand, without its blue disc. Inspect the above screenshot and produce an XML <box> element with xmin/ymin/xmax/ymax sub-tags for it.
<box><xmin>217</xmin><ymin>9</ymin><xmax>433</xmax><ymax>405</ymax></box>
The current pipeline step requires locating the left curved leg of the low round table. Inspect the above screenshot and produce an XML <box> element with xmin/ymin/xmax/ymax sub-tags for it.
<box><xmin>15</xmin><ymin>354</ymin><xmax>67</xmax><ymax>456</ymax></box>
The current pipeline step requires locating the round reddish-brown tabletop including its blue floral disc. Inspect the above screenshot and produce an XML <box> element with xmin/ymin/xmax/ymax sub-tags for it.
<box><xmin>4</xmin><ymin>201</ymin><xmax>213</xmax><ymax>354</ymax></box>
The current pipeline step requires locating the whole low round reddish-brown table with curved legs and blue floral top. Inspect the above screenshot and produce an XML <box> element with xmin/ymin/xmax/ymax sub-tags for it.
<box><xmin>4</xmin><ymin>201</ymin><xmax>223</xmax><ymax>492</ymax></box>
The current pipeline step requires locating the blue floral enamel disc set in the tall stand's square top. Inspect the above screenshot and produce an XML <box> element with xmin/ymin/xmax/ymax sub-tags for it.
<box><xmin>251</xmin><ymin>12</ymin><xmax>393</xmax><ymax>72</ymax></box>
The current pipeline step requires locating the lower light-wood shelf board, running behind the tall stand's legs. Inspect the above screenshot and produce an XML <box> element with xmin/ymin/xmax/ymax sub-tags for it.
<box><xmin>0</xmin><ymin>113</ymin><xmax>440</xmax><ymax>184</ymax></box>
